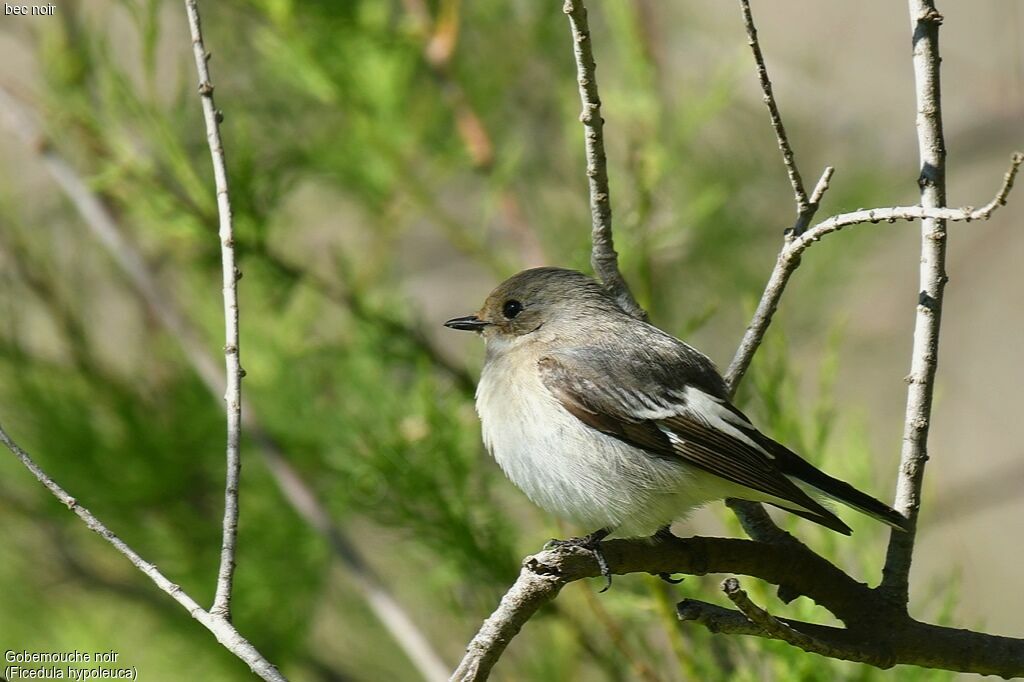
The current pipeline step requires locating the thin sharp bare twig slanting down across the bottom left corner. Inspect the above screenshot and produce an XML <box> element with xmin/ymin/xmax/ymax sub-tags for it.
<box><xmin>0</xmin><ymin>426</ymin><xmax>285</xmax><ymax>682</ymax></box>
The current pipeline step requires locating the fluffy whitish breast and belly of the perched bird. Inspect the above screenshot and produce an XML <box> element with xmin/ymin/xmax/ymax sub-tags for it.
<box><xmin>476</xmin><ymin>353</ymin><xmax>728</xmax><ymax>537</ymax></box>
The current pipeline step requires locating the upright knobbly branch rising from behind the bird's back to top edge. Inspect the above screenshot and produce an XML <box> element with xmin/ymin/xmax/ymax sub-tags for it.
<box><xmin>562</xmin><ymin>0</ymin><xmax>647</xmax><ymax>319</ymax></box>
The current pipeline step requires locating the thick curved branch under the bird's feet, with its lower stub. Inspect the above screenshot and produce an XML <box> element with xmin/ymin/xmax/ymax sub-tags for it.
<box><xmin>452</xmin><ymin>537</ymin><xmax>1024</xmax><ymax>682</ymax></box>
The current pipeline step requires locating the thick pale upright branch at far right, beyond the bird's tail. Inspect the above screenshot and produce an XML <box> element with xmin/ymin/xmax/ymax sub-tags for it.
<box><xmin>882</xmin><ymin>0</ymin><xmax>947</xmax><ymax>608</ymax></box>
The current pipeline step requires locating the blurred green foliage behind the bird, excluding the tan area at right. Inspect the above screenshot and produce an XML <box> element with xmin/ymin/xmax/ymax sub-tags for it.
<box><xmin>0</xmin><ymin>0</ymin><xmax>955</xmax><ymax>680</ymax></box>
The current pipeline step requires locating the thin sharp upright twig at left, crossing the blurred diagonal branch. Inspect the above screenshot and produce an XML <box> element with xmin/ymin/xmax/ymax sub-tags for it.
<box><xmin>185</xmin><ymin>0</ymin><xmax>242</xmax><ymax>621</ymax></box>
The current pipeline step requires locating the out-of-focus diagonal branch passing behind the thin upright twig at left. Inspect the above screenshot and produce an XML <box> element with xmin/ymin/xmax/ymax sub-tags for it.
<box><xmin>0</xmin><ymin>61</ymin><xmax>452</xmax><ymax>682</ymax></box>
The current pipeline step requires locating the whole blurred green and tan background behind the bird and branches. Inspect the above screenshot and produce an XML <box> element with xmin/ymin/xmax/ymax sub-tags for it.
<box><xmin>0</xmin><ymin>0</ymin><xmax>1024</xmax><ymax>681</ymax></box>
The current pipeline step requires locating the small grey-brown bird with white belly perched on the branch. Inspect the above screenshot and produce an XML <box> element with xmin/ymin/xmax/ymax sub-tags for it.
<box><xmin>444</xmin><ymin>267</ymin><xmax>907</xmax><ymax>577</ymax></box>
